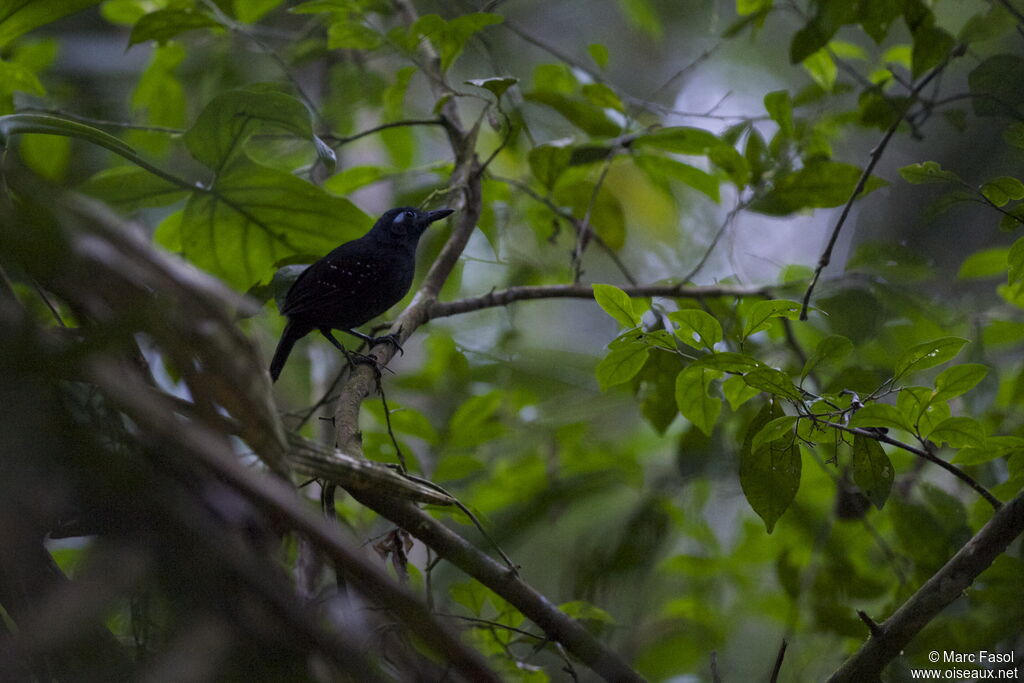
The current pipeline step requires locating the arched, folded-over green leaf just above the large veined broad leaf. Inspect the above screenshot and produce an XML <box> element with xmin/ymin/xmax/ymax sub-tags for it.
<box><xmin>183</xmin><ymin>86</ymin><xmax>312</xmax><ymax>172</ymax></box>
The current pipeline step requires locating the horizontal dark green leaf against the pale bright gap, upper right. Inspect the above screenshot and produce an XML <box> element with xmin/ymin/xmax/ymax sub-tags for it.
<box><xmin>750</xmin><ymin>160</ymin><xmax>889</xmax><ymax>216</ymax></box>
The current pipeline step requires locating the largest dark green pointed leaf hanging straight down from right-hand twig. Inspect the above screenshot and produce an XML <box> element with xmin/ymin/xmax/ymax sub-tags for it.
<box><xmin>739</xmin><ymin>402</ymin><xmax>802</xmax><ymax>533</ymax></box>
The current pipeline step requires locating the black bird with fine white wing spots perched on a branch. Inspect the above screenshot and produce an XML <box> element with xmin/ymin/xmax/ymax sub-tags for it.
<box><xmin>270</xmin><ymin>207</ymin><xmax>452</xmax><ymax>382</ymax></box>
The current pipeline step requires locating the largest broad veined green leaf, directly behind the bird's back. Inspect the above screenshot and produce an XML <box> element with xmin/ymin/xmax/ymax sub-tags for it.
<box><xmin>181</xmin><ymin>162</ymin><xmax>373</xmax><ymax>290</ymax></box>
